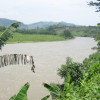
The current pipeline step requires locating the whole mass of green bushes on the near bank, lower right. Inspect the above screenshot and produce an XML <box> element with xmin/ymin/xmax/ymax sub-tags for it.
<box><xmin>43</xmin><ymin>53</ymin><xmax>100</xmax><ymax>100</ymax></box>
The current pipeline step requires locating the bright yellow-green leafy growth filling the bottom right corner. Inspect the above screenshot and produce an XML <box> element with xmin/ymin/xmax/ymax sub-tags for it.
<box><xmin>77</xmin><ymin>62</ymin><xmax>100</xmax><ymax>100</ymax></box>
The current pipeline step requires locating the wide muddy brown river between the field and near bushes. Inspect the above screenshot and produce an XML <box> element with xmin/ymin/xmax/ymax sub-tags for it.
<box><xmin>0</xmin><ymin>37</ymin><xmax>97</xmax><ymax>100</ymax></box>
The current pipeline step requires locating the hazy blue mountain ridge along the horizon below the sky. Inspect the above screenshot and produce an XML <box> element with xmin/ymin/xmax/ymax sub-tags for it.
<box><xmin>0</xmin><ymin>18</ymin><xmax>75</xmax><ymax>29</ymax></box>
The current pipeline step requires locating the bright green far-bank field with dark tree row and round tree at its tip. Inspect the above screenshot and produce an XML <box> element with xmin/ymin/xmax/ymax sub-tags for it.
<box><xmin>0</xmin><ymin>27</ymin><xmax>73</xmax><ymax>43</ymax></box>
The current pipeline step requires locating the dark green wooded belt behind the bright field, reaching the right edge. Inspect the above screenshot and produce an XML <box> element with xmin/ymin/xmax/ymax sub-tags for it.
<box><xmin>0</xmin><ymin>24</ymin><xmax>100</xmax><ymax>38</ymax></box>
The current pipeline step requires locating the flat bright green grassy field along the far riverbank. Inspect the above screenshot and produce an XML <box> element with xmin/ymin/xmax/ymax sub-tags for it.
<box><xmin>0</xmin><ymin>32</ymin><xmax>64</xmax><ymax>43</ymax></box>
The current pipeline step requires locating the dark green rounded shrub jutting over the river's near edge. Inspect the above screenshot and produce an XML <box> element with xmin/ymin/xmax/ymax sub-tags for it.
<box><xmin>58</xmin><ymin>58</ymin><xmax>83</xmax><ymax>83</ymax></box>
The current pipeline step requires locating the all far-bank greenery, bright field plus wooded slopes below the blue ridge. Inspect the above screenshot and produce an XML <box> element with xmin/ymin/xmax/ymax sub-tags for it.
<box><xmin>0</xmin><ymin>24</ymin><xmax>100</xmax><ymax>42</ymax></box>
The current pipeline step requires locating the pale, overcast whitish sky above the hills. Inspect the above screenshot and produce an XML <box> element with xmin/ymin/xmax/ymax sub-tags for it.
<box><xmin>0</xmin><ymin>0</ymin><xmax>100</xmax><ymax>26</ymax></box>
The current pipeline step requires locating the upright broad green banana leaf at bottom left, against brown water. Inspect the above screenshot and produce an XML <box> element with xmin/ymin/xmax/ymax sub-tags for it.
<box><xmin>9</xmin><ymin>82</ymin><xmax>30</xmax><ymax>100</ymax></box>
